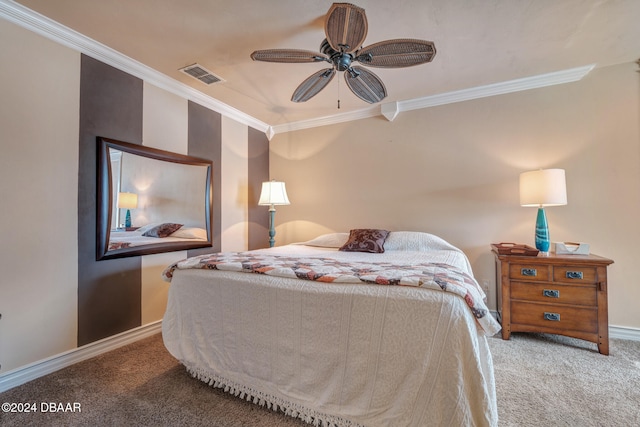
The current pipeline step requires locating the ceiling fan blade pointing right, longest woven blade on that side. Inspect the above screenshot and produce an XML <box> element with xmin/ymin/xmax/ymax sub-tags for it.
<box><xmin>355</xmin><ymin>39</ymin><xmax>436</xmax><ymax>68</ymax></box>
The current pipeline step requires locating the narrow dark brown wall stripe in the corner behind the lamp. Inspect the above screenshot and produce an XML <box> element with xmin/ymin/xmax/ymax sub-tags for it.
<box><xmin>247</xmin><ymin>128</ymin><xmax>269</xmax><ymax>250</ymax></box>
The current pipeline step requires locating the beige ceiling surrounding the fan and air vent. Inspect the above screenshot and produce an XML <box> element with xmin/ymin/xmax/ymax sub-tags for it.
<box><xmin>8</xmin><ymin>0</ymin><xmax>640</xmax><ymax>130</ymax></box>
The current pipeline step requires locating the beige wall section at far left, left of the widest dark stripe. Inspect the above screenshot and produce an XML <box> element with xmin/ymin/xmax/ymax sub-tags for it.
<box><xmin>0</xmin><ymin>20</ymin><xmax>80</xmax><ymax>371</ymax></box>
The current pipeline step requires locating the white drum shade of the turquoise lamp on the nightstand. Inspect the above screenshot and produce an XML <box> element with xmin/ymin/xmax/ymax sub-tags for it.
<box><xmin>520</xmin><ymin>169</ymin><xmax>567</xmax><ymax>207</ymax></box>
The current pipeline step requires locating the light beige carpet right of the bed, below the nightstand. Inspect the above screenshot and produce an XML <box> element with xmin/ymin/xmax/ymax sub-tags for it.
<box><xmin>489</xmin><ymin>333</ymin><xmax>640</xmax><ymax>427</ymax></box>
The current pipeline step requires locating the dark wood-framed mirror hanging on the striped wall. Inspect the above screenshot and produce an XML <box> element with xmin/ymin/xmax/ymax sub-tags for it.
<box><xmin>96</xmin><ymin>137</ymin><xmax>213</xmax><ymax>260</ymax></box>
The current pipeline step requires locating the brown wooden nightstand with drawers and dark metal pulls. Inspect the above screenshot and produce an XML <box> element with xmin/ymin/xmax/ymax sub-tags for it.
<box><xmin>493</xmin><ymin>250</ymin><xmax>613</xmax><ymax>354</ymax></box>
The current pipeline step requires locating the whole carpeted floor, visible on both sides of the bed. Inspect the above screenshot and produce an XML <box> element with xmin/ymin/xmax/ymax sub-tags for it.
<box><xmin>0</xmin><ymin>334</ymin><xmax>640</xmax><ymax>427</ymax></box>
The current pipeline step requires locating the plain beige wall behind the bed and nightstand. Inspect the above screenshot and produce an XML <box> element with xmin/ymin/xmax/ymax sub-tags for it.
<box><xmin>270</xmin><ymin>63</ymin><xmax>640</xmax><ymax>328</ymax></box>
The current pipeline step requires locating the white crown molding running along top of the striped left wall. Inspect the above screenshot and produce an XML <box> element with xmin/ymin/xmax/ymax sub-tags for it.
<box><xmin>0</xmin><ymin>0</ymin><xmax>270</xmax><ymax>132</ymax></box>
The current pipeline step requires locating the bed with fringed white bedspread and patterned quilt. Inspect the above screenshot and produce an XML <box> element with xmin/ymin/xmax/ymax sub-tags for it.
<box><xmin>162</xmin><ymin>230</ymin><xmax>500</xmax><ymax>427</ymax></box>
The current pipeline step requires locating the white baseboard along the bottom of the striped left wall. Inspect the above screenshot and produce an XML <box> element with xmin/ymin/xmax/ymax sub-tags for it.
<box><xmin>0</xmin><ymin>320</ymin><xmax>162</xmax><ymax>393</ymax></box>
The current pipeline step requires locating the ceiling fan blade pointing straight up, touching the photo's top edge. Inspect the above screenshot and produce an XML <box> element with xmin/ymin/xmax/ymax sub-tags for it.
<box><xmin>324</xmin><ymin>3</ymin><xmax>368</xmax><ymax>53</ymax></box>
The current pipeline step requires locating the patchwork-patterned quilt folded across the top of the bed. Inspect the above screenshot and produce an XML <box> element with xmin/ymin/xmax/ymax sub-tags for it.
<box><xmin>162</xmin><ymin>252</ymin><xmax>500</xmax><ymax>335</ymax></box>
